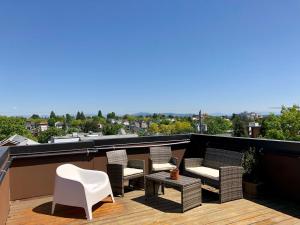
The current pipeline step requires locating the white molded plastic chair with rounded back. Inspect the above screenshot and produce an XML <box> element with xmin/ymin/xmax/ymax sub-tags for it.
<box><xmin>52</xmin><ymin>164</ymin><xmax>115</xmax><ymax>220</ymax></box>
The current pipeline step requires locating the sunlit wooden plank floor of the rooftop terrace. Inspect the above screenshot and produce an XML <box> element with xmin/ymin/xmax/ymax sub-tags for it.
<box><xmin>7</xmin><ymin>188</ymin><xmax>300</xmax><ymax>225</ymax></box>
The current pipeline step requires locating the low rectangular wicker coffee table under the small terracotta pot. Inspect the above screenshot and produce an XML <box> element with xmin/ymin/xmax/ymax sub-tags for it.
<box><xmin>145</xmin><ymin>172</ymin><xmax>202</xmax><ymax>212</ymax></box>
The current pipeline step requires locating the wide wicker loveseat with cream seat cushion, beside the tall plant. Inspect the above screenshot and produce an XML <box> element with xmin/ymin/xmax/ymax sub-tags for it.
<box><xmin>184</xmin><ymin>148</ymin><xmax>243</xmax><ymax>203</ymax></box>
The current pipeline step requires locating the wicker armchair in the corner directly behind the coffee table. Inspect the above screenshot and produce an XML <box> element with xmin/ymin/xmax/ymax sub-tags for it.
<box><xmin>149</xmin><ymin>146</ymin><xmax>178</xmax><ymax>172</ymax></box>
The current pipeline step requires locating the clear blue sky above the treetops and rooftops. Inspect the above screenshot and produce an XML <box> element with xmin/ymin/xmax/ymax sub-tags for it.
<box><xmin>0</xmin><ymin>0</ymin><xmax>300</xmax><ymax>115</ymax></box>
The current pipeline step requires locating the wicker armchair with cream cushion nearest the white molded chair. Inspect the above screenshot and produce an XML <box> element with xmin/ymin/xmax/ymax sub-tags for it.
<box><xmin>106</xmin><ymin>150</ymin><xmax>145</xmax><ymax>196</ymax></box>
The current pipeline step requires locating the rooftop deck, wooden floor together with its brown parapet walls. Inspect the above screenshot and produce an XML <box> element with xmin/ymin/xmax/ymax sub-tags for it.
<box><xmin>0</xmin><ymin>134</ymin><xmax>300</xmax><ymax>225</ymax></box>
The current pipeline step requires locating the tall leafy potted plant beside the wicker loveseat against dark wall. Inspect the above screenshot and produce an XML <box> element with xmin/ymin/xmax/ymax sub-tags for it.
<box><xmin>243</xmin><ymin>147</ymin><xmax>263</xmax><ymax>197</ymax></box>
